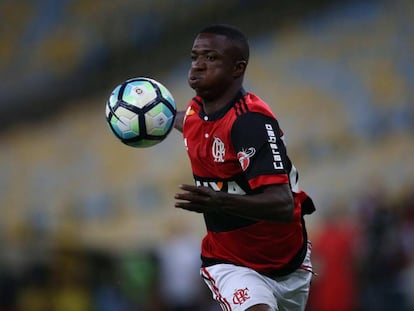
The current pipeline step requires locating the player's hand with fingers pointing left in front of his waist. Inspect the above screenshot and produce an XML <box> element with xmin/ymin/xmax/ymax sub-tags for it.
<box><xmin>175</xmin><ymin>185</ymin><xmax>220</xmax><ymax>213</ymax></box>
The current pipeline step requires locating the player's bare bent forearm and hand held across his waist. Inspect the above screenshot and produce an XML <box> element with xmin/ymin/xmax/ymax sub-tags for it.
<box><xmin>175</xmin><ymin>184</ymin><xmax>294</xmax><ymax>222</ymax></box>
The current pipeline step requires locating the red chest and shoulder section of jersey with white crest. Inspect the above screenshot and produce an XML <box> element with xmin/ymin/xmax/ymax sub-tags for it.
<box><xmin>183</xmin><ymin>93</ymin><xmax>274</xmax><ymax>185</ymax></box>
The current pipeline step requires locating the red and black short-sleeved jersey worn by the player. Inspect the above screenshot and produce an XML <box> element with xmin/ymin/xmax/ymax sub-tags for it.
<box><xmin>183</xmin><ymin>89</ymin><xmax>314</xmax><ymax>275</ymax></box>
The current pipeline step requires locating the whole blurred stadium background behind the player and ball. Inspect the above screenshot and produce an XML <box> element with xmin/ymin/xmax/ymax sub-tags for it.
<box><xmin>0</xmin><ymin>0</ymin><xmax>414</xmax><ymax>311</ymax></box>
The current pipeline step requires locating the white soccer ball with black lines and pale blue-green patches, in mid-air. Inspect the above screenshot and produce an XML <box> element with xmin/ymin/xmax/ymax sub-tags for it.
<box><xmin>105</xmin><ymin>77</ymin><xmax>177</xmax><ymax>148</ymax></box>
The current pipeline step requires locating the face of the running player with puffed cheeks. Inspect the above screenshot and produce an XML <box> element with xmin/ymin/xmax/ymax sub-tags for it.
<box><xmin>188</xmin><ymin>34</ymin><xmax>240</xmax><ymax>100</ymax></box>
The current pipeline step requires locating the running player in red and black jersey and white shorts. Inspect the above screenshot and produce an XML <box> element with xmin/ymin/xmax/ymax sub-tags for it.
<box><xmin>175</xmin><ymin>25</ymin><xmax>314</xmax><ymax>311</ymax></box>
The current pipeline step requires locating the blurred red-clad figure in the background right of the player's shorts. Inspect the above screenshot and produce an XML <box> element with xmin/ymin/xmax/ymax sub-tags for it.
<box><xmin>307</xmin><ymin>202</ymin><xmax>360</xmax><ymax>311</ymax></box>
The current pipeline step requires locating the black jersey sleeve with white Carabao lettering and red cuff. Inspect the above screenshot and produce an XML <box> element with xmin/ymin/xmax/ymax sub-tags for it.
<box><xmin>231</xmin><ymin>112</ymin><xmax>291</xmax><ymax>189</ymax></box>
